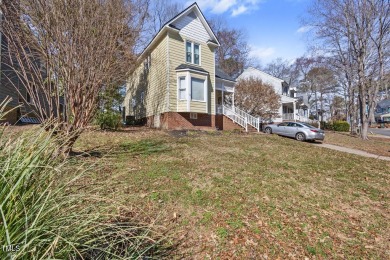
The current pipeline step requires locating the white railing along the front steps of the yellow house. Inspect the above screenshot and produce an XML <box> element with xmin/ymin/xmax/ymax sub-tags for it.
<box><xmin>222</xmin><ymin>106</ymin><xmax>260</xmax><ymax>132</ymax></box>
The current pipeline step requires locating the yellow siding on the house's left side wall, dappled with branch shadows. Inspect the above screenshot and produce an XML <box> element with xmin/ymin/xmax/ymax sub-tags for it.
<box><xmin>124</xmin><ymin>33</ymin><xmax>168</xmax><ymax>118</ymax></box>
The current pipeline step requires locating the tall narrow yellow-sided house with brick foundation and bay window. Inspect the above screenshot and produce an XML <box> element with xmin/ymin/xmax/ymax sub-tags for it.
<box><xmin>123</xmin><ymin>3</ymin><xmax>241</xmax><ymax>129</ymax></box>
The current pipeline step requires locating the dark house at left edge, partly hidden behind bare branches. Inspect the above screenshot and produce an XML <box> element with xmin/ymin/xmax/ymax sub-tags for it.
<box><xmin>0</xmin><ymin>10</ymin><xmax>39</xmax><ymax>124</ymax></box>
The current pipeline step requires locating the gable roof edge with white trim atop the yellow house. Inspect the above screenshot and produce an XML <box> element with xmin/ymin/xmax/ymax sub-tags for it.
<box><xmin>140</xmin><ymin>2</ymin><xmax>220</xmax><ymax>58</ymax></box>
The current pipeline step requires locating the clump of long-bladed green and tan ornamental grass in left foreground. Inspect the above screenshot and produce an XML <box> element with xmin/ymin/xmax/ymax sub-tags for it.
<box><xmin>0</xmin><ymin>98</ymin><xmax>163</xmax><ymax>259</ymax></box>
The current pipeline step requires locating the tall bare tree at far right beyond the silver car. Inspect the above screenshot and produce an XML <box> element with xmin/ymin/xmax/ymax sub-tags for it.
<box><xmin>307</xmin><ymin>0</ymin><xmax>390</xmax><ymax>139</ymax></box>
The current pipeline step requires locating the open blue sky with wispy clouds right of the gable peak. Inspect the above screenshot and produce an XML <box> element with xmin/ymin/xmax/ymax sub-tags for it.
<box><xmin>178</xmin><ymin>0</ymin><xmax>311</xmax><ymax>65</ymax></box>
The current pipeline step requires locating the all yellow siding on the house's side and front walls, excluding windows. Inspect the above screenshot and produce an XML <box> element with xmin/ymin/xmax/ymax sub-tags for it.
<box><xmin>124</xmin><ymin>24</ymin><xmax>215</xmax><ymax>118</ymax></box>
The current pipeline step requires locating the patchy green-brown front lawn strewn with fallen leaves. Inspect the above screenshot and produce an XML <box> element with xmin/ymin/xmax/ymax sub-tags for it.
<box><xmin>68</xmin><ymin>128</ymin><xmax>390</xmax><ymax>259</ymax></box>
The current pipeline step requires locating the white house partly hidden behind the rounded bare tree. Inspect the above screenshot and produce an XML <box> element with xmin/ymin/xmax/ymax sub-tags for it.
<box><xmin>237</xmin><ymin>67</ymin><xmax>298</xmax><ymax>122</ymax></box>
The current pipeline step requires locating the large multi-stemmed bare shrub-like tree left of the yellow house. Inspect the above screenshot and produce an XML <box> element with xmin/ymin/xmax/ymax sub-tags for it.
<box><xmin>1</xmin><ymin>0</ymin><xmax>146</xmax><ymax>150</ymax></box>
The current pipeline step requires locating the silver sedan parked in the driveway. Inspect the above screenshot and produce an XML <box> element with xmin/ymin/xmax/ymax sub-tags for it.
<box><xmin>264</xmin><ymin>122</ymin><xmax>325</xmax><ymax>141</ymax></box>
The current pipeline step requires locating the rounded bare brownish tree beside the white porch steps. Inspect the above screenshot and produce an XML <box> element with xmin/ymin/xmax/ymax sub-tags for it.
<box><xmin>234</xmin><ymin>78</ymin><xmax>280</xmax><ymax>118</ymax></box>
